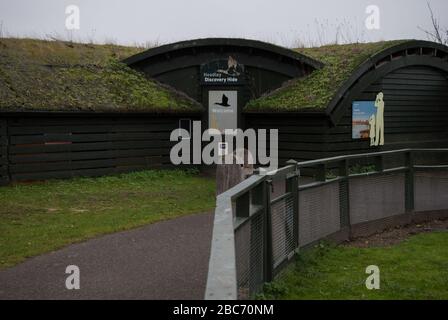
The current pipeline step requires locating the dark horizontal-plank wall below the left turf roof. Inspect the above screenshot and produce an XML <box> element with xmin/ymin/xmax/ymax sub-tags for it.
<box><xmin>0</xmin><ymin>114</ymin><xmax>198</xmax><ymax>181</ymax></box>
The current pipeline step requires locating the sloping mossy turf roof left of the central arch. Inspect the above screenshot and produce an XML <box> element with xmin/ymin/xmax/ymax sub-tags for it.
<box><xmin>0</xmin><ymin>38</ymin><xmax>201</xmax><ymax>112</ymax></box>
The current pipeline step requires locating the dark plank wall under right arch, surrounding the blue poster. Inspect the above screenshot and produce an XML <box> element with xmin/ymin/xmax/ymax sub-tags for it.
<box><xmin>328</xmin><ymin>66</ymin><xmax>448</xmax><ymax>154</ymax></box>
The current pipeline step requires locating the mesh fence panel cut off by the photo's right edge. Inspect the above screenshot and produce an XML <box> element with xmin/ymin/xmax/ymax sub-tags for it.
<box><xmin>414</xmin><ymin>171</ymin><xmax>448</xmax><ymax>211</ymax></box>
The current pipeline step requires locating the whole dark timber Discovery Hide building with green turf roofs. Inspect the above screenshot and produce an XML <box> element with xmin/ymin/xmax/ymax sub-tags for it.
<box><xmin>0</xmin><ymin>38</ymin><xmax>448</xmax><ymax>182</ymax></box>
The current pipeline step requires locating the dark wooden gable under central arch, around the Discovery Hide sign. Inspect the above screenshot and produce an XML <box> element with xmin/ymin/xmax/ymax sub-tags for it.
<box><xmin>131</xmin><ymin>46</ymin><xmax>314</xmax><ymax>106</ymax></box>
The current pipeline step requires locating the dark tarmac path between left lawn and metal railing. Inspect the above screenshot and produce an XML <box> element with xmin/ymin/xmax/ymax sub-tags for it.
<box><xmin>0</xmin><ymin>213</ymin><xmax>213</xmax><ymax>299</ymax></box>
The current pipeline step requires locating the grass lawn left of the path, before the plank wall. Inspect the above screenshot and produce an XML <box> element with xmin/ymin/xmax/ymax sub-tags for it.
<box><xmin>0</xmin><ymin>170</ymin><xmax>215</xmax><ymax>268</ymax></box>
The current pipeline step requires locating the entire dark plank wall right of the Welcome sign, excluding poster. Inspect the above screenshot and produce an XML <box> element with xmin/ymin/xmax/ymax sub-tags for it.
<box><xmin>245</xmin><ymin>66</ymin><xmax>448</xmax><ymax>163</ymax></box>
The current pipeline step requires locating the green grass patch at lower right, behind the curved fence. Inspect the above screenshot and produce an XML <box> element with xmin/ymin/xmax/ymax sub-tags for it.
<box><xmin>258</xmin><ymin>232</ymin><xmax>448</xmax><ymax>299</ymax></box>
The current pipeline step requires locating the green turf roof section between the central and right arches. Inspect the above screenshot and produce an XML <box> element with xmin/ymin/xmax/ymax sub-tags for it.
<box><xmin>245</xmin><ymin>40</ymin><xmax>407</xmax><ymax>112</ymax></box>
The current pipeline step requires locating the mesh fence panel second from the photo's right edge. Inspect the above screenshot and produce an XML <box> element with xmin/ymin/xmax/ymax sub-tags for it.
<box><xmin>349</xmin><ymin>173</ymin><xmax>406</xmax><ymax>224</ymax></box>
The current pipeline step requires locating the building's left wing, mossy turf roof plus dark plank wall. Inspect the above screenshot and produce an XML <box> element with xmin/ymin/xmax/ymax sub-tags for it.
<box><xmin>0</xmin><ymin>39</ymin><xmax>203</xmax><ymax>183</ymax></box>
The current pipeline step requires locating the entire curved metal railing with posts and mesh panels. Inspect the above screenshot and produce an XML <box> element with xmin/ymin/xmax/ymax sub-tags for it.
<box><xmin>206</xmin><ymin>149</ymin><xmax>448</xmax><ymax>299</ymax></box>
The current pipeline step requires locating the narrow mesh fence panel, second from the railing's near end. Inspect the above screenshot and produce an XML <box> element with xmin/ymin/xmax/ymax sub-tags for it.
<box><xmin>271</xmin><ymin>194</ymin><xmax>295</xmax><ymax>268</ymax></box>
